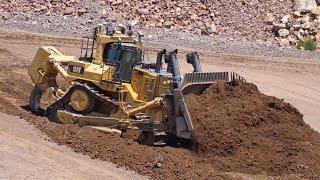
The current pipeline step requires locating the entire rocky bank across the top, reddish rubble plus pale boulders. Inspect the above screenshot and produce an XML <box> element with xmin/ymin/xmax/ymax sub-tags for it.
<box><xmin>0</xmin><ymin>0</ymin><xmax>320</xmax><ymax>47</ymax></box>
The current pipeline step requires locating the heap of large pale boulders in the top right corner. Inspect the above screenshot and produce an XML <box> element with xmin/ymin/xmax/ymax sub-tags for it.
<box><xmin>265</xmin><ymin>0</ymin><xmax>320</xmax><ymax>48</ymax></box>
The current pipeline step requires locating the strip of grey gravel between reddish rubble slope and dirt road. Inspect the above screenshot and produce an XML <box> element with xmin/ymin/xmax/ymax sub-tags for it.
<box><xmin>0</xmin><ymin>12</ymin><xmax>320</xmax><ymax>60</ymax></box>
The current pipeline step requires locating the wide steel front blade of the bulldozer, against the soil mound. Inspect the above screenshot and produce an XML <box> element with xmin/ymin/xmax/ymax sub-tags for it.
<box><xmin>174</xmin><ymin>72</ymin><xmax>245</xmax><ymax>139</ymax></box>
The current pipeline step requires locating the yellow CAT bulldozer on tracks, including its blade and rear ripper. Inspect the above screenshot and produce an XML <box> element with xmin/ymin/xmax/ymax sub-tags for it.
<box><xmin>28</xmin><ymin>24</ymin><xmax>244</xmax><ymax>145</ymax></box>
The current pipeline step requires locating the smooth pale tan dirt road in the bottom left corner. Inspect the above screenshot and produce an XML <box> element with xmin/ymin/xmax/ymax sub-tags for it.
<box><xmin>0</xmin><ymin>113</ymin><xmax>147</xmax><ymax>179</ymax></box>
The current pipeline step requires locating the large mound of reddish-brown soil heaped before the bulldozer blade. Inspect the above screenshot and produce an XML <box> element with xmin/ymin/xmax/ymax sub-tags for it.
<box><xmin>186</xmin><ymin>81</ymin><xmax>320</xmax><ymax>177</ymax></box>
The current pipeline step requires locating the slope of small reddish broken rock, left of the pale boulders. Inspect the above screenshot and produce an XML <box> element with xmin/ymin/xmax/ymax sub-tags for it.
<box><xmin>0</xmin><ymin>0</ymin><xmax>293</xmax><ymax>37</ymax></box>
